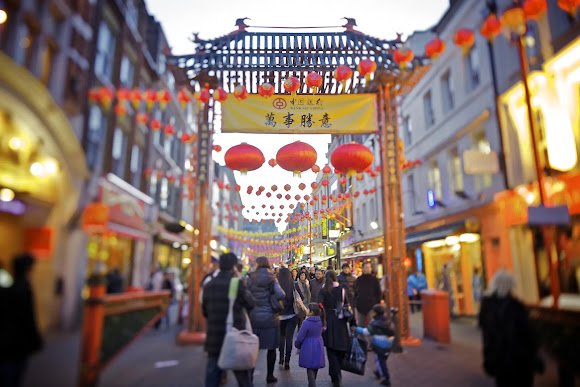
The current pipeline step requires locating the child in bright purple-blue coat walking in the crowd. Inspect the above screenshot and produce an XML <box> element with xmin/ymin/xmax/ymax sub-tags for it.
<box><xmin>294</xmin><ymin>303</ymin><xmax>325</xmax><ymax>387</ymax></box>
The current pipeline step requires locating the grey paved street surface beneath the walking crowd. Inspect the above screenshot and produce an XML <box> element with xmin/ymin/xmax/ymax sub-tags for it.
<box><xmin>25</xmin><ymin>314</ymin><xmax>556</xmax><ymax>387</ymax></box>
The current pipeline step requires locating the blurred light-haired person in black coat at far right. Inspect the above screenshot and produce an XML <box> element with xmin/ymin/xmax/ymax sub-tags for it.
<box><xmin>479</xmin><ymin>270</ymin><xmax>541</xmax><ymax>387</ymax></box>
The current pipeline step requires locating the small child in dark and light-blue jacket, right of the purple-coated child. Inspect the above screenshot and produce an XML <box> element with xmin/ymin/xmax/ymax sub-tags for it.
<box><xmin>356</xmin><ymin>304</ymin><xmax>395</xmax><ymax>386</ymax></box>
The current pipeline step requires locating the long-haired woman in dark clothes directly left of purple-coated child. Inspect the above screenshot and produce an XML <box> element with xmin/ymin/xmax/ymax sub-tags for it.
<box><xmin>278</xmin><ymin>267</ymin><xmax>304</xmax><ymax>370</ymax></box>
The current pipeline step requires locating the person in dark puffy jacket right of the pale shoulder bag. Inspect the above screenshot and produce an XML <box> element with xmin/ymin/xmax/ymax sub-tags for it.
<box><xmin>248</xmin><ymin>257</ymin><xmax>286</xmax><ymax>383</ymax></box>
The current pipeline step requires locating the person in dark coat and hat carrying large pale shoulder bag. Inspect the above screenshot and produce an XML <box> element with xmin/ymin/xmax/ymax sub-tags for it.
<box><xmin>202</xmin><ymin>253</ymin><xmax>254</xmax><ymax>387</ymax></box>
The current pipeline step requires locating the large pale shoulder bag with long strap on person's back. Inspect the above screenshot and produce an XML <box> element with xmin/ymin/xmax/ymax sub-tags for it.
<box><xmin>218</xmin><ymin>278</ymin><xmax>260</xmax><ymax>371</ymax></box>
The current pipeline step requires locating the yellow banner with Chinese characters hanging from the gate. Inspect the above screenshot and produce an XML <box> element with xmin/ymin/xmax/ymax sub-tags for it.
<box><xmin>222</xmin><ymin>94</ymin><xmax>377</xmax><ymax>134</ymax></box>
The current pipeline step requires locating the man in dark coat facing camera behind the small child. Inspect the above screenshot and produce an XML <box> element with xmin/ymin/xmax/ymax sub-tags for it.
<box><xmin>354</xmin><ymin>262</ymin><xmax>381</xmax><ymax>327</ymax></box>
